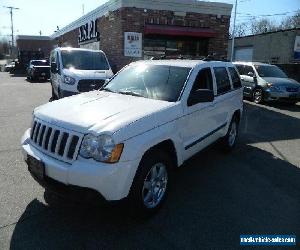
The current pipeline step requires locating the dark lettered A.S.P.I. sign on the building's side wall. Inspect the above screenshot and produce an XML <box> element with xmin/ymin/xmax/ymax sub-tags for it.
<box><xmin>78</xmin><ymin>19</ymin><xmax>100</xmax><ymax>44</ymax></box>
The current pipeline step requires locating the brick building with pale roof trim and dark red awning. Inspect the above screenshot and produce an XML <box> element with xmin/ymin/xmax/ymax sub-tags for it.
<box><xmin>51</xmin><ymin>0</ymin><xmax>232</xmax><ymax>69</ymax></box>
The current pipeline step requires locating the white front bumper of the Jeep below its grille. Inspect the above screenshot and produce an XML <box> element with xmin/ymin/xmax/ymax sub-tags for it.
<box><xmin>22</xmin><ymin>130</ymin><xmax>139</xmax><ymax>201</ymax></box>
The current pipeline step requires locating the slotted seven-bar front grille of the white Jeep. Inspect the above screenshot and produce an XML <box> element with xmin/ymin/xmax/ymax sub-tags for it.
<box><xmin>30</xmin><ymin>118</ymin><xmax>83</xmax><ymax>163</ymax></box>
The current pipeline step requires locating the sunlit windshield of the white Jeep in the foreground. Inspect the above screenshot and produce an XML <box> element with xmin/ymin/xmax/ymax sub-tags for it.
<box><xmin>104</xmin><ymin>63</ymin><xmax>191</xmax><ymax>102</ymax></box>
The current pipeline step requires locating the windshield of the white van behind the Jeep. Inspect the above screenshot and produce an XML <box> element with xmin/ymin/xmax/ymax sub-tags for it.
<box><xmin>61</xmin><ymin>50</ymin><xmax>109</xmax><ymax>70</ymax></box>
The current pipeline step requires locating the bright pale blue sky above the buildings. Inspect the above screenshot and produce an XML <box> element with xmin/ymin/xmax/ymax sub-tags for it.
<box><xmin>0</xmin><ymin>0</ymin><xmax>300</xmax><ymax>38</ymax></box>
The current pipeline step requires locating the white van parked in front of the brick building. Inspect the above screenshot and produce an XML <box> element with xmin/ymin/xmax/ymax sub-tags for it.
<box><xmin>50</xmin><ymin>47</ymin><xmax>113</xmax><ymax>100</ymax></box>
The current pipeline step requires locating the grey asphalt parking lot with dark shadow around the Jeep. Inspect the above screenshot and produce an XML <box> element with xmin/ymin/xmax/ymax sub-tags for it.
<box><xmin>0</xmin><ymin>72</ymin><xmax>300</xmax><ymax>249</ymax></box>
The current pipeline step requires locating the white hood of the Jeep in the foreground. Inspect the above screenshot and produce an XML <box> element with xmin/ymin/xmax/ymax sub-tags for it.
<box><xmin>34</xmin><ymin>91</ymin><xmax>176</xmax><ymax>139</ymax></box>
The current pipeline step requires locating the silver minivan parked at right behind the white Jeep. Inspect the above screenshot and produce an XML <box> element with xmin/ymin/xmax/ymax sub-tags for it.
<box><xmin>234</xmin><ymin>62</ymin><xmax>300</xmax><ymax>104</ymax></box>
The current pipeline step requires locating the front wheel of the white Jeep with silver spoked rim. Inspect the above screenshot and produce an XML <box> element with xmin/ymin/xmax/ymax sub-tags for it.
<box><xmin>128</xmin><ymin>152</ymin><xmax>172</xmax><ymax>216</ymax></box>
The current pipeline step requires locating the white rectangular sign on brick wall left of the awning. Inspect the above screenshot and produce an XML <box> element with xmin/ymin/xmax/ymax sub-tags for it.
<box><xmin>124</xmin><ymin>32</ymin><xmax>142</xmax><ymax>57</ymax></box>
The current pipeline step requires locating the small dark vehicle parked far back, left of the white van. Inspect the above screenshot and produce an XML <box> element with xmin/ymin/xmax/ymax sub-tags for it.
<box><xmin>27</xmin><ymin>60</ymin><xmax>50</xmax><ymax>81</ymax></box>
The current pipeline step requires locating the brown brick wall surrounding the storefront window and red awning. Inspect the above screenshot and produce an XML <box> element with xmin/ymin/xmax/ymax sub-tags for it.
<box><xmin>98</xmin><ymin>8</ymin><xmax>230</xmax><ymax>68</ymax></box>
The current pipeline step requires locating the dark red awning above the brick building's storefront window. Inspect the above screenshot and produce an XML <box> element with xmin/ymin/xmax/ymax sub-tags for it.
<box><xmin>144</xmin><ymin>24</ymin><xmax>216</xmax><ymax>37</ymax></box>
